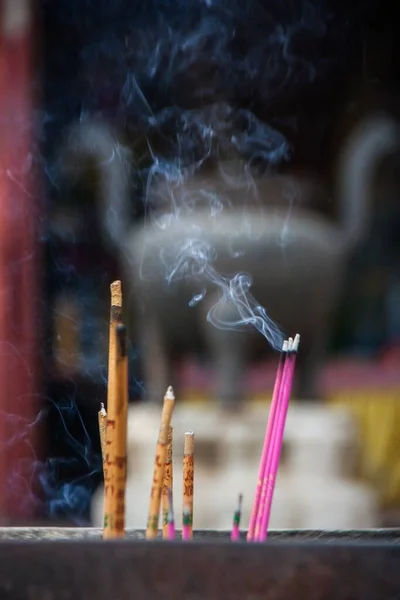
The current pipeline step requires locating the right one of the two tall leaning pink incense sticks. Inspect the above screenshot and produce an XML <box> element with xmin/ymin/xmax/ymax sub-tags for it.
<box><xmin>257</xmin><ymin>334</ymin><xmax>300</xmax><ymax>542</ymax></box>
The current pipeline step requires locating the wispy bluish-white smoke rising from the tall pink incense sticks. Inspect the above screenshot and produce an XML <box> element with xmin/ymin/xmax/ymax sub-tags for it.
<box><xmin>45</xmin><ymin>0</ymin><xmax>368</xmax><ymax>348</ymax></box>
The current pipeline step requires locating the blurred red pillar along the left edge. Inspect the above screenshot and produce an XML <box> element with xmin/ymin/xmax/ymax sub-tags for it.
<box><xmin>0</xmin><ymin>0</ymin><xmax>40</xmax><ymax>523</ymax></box>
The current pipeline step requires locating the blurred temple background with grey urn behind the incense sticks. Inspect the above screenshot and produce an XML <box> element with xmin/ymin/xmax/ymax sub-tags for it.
<box><xmin>0</xmin><ymin>0</ymin><xmax>400</xmax><ymax>528</ymax></box>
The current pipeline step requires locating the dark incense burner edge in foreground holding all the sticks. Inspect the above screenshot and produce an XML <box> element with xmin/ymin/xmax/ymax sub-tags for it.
<box><xmin>0</xmin><ymin>528</ymin><xmax>400</xmax><ymax>600</ymax></box>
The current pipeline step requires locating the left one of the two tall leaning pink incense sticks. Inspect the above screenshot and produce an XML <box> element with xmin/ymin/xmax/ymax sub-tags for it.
<box><xmin>247</xmin><ymin>340</ymin><xmax>288</xmax><ymax>542</ymax></box>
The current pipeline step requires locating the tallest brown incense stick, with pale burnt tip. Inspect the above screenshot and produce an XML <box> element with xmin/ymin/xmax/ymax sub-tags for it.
<box><xmin>104</xmin><ymin>281</ymin><xmax>122</xmax><ymax>539</ymax></box>
